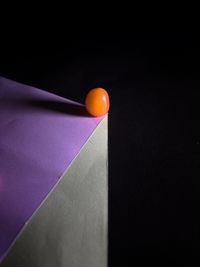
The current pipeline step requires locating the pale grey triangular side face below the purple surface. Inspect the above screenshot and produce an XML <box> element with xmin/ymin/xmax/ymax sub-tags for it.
<box><xmin>1</xmin><ymin>117</ymin><xmax>108</xmax><ymax>267</ymax></box>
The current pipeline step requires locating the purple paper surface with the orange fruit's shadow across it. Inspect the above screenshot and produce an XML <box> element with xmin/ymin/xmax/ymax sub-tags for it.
<box><xmin>0</xmin><ymin>77</ymin><xmax>102</xmax><ymax>260</ymax></box>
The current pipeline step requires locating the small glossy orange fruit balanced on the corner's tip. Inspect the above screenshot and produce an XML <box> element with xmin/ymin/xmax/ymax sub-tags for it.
<box><xmin>85</xmin><ymin>88</ymin><xmax>110</xmax><ymax>117</ymax></box>
